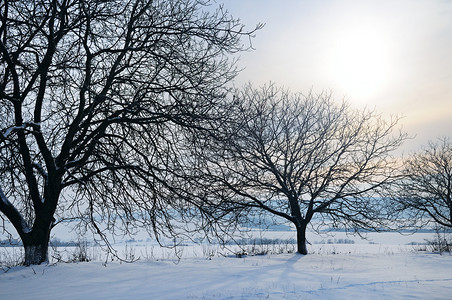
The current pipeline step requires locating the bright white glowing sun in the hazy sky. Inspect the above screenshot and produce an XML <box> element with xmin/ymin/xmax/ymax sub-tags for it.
<box><xmin>329</xmin><ymin>28</ymin><xmax>391</xmax><ymax>102</ymax></box>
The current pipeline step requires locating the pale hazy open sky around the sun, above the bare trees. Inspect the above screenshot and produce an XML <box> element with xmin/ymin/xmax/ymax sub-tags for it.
<box><xmin>216</xmin><ymin>0</ymin><xmax>452</xmax><ymax>152</ymax></box>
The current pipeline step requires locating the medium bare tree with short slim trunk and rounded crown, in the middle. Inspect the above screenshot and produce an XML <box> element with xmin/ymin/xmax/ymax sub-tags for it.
<box><xmin>200</xmin><ymin>85</ymin><xmax>406</xmax><ymax>254</ymax></box>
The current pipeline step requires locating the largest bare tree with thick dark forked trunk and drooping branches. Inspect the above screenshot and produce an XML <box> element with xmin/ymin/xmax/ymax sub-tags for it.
<box><xmin>0</xmin><ymin>0</ymin><xmax>261</xmax><ymax>265</ymax></box>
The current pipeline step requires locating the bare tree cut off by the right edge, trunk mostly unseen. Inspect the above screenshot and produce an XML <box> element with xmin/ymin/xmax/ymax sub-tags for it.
<box><xmin>395</xmin><ymin>138</ymin><xmax>452</xmax><ymax>228</ymax></box>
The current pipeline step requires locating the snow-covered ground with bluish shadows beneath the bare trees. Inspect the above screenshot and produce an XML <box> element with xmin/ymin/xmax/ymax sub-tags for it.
<box><xmin>0</xmin><ymin>232</ymin><xmax>452</xmax><ymax>299</ymax></box>
